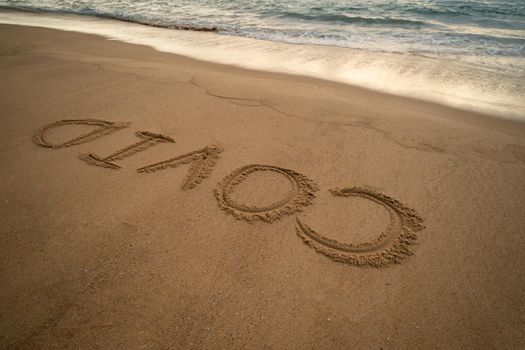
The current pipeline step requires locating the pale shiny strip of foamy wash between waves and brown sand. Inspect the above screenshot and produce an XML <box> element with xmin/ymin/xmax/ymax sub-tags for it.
<box><xmin>0</xmin><ymin>11</ymin><xmax>525</xmax><ymax>120</ymax></box>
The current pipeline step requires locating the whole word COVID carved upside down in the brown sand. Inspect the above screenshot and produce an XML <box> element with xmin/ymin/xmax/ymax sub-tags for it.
<box><xmin>33</xmin><ymin>119</ymin><xmax>424</xmax><ymax>267</ymax></box>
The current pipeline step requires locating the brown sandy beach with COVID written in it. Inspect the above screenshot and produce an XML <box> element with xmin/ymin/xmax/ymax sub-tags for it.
<box><xmin>0</xmin><ymin>25</ymin><xmax>525</xmax><ymax>349</ymax></box>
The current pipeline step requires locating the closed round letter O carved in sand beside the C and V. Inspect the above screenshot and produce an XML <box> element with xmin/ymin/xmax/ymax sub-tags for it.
<box><xmin>215</xmin><ymin>164</ymin><xmax>318</xmax><ymax>222</ymax></box>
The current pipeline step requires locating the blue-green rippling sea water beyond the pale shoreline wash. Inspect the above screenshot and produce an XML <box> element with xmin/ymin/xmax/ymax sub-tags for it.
<box><xmin>0</xmin><ymin>0</ymin><xmax>525</xmax><ymax>63</ymax></box>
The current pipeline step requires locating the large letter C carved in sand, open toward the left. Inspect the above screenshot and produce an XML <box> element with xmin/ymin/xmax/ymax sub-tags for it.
<box><xmin>295</xmin><ymin>187</ymin><xmax>424</xmax><ymax>267</ymax></box>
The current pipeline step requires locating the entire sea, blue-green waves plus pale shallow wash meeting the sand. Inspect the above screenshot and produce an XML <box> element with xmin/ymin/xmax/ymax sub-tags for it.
<box><xmin>0</xmin><ymin>0</ymin><xmax>525</xmax><ymax>120</ymax></box>
